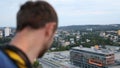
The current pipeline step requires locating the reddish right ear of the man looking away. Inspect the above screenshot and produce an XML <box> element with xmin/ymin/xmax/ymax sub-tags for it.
<box><xmin>45</xmin><ymin>22</ymin><xmax>56</xmax><ymax>40</ymax></box>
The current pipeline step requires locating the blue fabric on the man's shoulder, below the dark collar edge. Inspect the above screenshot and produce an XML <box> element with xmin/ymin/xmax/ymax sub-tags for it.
<box><xmin>0</xmin><ymin>50</ymin><xmax>17</xmax><ymax>68</ymax></box>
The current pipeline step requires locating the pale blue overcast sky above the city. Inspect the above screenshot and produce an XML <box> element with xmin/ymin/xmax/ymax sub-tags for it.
<box><xmin>0</xmin><ymin>0</ymin><xmax>120</xmax><ymax>26</ymax></box>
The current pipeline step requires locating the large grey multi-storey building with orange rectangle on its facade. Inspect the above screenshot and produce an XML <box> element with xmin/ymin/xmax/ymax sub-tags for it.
<box><xmin>70</xmin><ymin>47</ymin><xmax>115</xmax><ymax>68</ymax></box>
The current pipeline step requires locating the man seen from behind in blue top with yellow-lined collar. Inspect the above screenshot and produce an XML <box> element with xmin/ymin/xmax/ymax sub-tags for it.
<box><xmin>0</xmin><ymin>1</ymin><xmax>58</xmax><ymax>68</ymax></box>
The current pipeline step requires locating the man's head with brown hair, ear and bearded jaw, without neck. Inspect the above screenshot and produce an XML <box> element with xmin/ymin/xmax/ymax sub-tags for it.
<box><xmin>16</xmin><ymin>1</ymin><xmax>58</xmax><ymax>57</ymax></box>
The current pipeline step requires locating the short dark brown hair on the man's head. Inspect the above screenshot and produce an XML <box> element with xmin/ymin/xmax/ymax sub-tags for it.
<box><xmin>16</xmin><ymin>1</ymin><xmax>58</xmax><ymax>32</ymax></box>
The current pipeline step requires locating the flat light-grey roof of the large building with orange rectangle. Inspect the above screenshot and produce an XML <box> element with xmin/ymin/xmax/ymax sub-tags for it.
<box><xmin>72</xmin><ymin>47</ymin><xmax>114</xmax><ymax>55</ymax></box>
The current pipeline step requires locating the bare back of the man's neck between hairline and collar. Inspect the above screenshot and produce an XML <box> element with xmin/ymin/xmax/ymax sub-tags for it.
<box><xmin>10</xmin><ymin>32</ymin><xmax>42</xmax><ymax>64</ymax></box>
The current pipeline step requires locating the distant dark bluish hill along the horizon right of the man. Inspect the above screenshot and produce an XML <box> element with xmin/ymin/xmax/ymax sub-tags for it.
<box><xmin>58</xmin><ymin>24</ymin><xmax>120</xmax><ymax>31</ymax></box>
